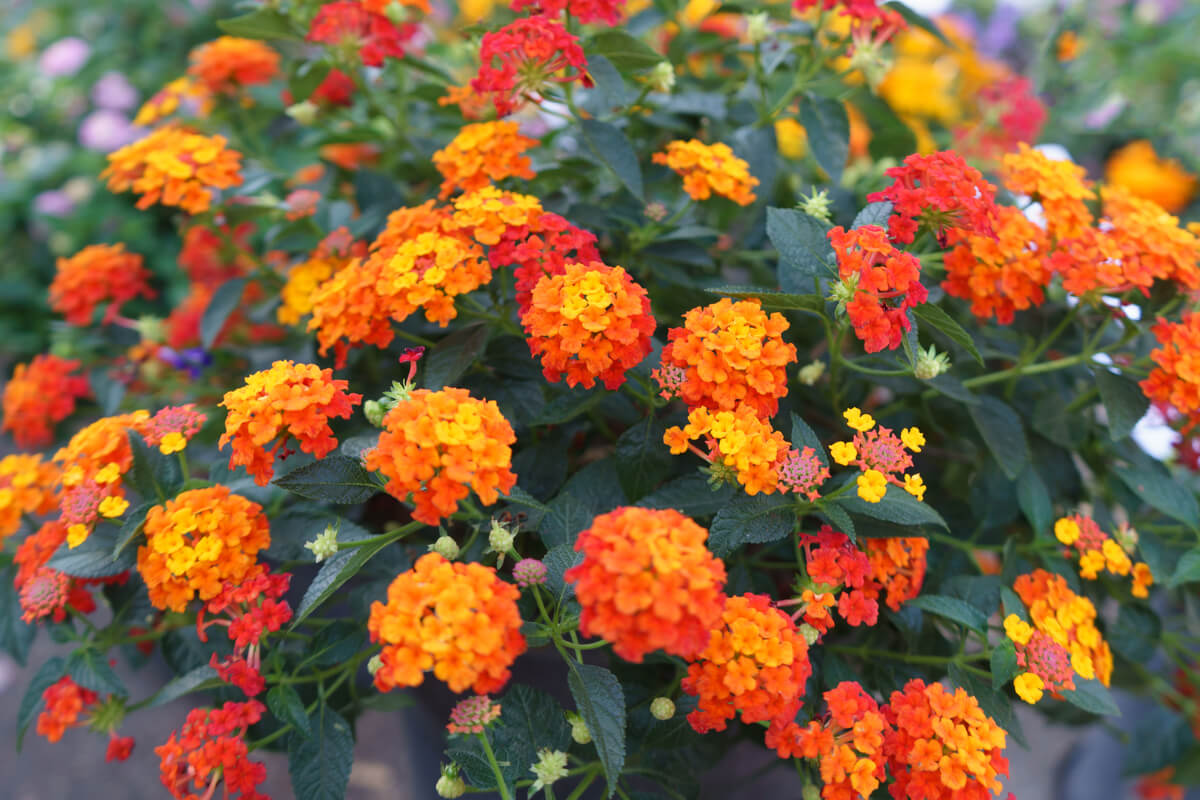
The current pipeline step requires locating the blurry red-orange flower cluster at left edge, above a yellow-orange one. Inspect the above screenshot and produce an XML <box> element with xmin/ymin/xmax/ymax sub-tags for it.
<box><xmin>0</xmin><ymin>354</ymin><xmax>91</xmax><ymax>447</ymax></box>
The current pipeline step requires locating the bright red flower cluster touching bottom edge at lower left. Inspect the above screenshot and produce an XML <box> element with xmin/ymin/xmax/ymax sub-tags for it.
<box><xmin>154</xmin><ymin>700</ymin><xmax>266</xmax><ymax>800</ymax></box>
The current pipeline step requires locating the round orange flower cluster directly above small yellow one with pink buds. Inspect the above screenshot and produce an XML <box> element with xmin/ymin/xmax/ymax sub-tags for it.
<box><xmin>656</xmin><ymin>297</ymin><xmax>796</xmax><ymax>417</ymax></box>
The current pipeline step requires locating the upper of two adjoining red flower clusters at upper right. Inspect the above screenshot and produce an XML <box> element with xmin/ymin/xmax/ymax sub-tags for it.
<box><xmin>866</xmin><ymin>150</ymin><xmax>996</xmax><ymax>246</ymax></box>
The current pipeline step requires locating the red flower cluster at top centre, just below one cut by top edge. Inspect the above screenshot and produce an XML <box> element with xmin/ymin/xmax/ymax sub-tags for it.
<box><xmin>470</xmin><ymin>14</ymin><xmax>589</xmax><ymax>116</ymax></box>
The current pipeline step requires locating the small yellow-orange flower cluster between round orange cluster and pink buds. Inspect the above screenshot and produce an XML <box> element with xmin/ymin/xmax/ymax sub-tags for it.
<box><xmin>662</xmin><ymin>408</ymin><xmax>792</xmax><ymax>494</ymax></box>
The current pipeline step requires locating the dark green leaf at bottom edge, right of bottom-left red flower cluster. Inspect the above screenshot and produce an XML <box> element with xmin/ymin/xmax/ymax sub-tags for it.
<box><xmin>288</xmin><ymin>703</ymin><xmax>354</xmax><ymax>800</ymax></box>
